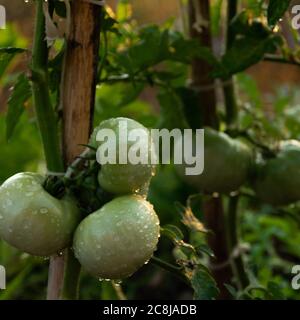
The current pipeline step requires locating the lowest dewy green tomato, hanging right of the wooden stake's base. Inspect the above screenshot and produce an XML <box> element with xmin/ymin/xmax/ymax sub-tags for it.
<box><xmin>73</xmin><ymin>195</ymin><xmax>160</xmax><ymax>279</ymax></box>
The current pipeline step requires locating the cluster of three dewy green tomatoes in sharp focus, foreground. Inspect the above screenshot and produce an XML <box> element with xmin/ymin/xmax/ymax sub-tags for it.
<box><xmin>0</xmin><ymin>118</ymin><xmax>160</xmax><ymax>279</ymax></box>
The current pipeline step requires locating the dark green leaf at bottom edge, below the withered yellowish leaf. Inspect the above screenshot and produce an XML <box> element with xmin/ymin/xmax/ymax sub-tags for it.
<box><xmin>191</xmin><ymin>266</ymin><xmax>219</xmax><ymax>300</ymax></box>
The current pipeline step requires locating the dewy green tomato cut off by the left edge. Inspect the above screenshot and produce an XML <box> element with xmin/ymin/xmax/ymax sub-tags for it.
<box><xmin>0</xmin><ymin>172</ymin><xmax>80</xmax><ymax>256</ymax></box>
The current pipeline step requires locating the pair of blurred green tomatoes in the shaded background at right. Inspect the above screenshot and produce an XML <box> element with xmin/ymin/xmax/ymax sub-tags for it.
<box><xmin>176</xmin><ymin>128</ymin><xmax>300</xmax><ymax>205</ymax></box>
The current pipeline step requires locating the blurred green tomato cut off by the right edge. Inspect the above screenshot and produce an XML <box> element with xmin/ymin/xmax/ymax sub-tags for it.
<box><xmin>255</xmin><ymin>140</ymin><xmax>300</xmax><ymax>205</ymax></box>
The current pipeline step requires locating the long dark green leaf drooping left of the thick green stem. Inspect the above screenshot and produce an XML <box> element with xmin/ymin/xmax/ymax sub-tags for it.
<box><xmin>6</xmin><ymin>73</ymin><xmax>31</xmax><ymax>140</ymax></box>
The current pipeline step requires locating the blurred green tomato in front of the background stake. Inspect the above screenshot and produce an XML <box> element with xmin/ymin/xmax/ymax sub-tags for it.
<box><xmin>176</xmin><ymin>128</ymin><xmax>253</xmax><ymax>193</ymax></box>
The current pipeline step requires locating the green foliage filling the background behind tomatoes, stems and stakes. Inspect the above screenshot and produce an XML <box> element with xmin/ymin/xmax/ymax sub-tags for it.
<box><xmin>0</xmin><ymin>0</ymin><xmax>300</xmax><ymax>299</ymax></box>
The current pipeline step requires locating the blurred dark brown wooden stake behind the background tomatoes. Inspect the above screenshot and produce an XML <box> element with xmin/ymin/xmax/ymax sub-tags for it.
<box><xmin>189</xmin><ymin>0</ymin><xmax>232</xmax><ymax>299</ymax></box>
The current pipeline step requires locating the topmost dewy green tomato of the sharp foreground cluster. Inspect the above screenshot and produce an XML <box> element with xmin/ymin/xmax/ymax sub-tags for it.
<box><xmin>90</xmin><ymin>118</ymin><xmax>155</xmax><ymax>194</ymax></box>
